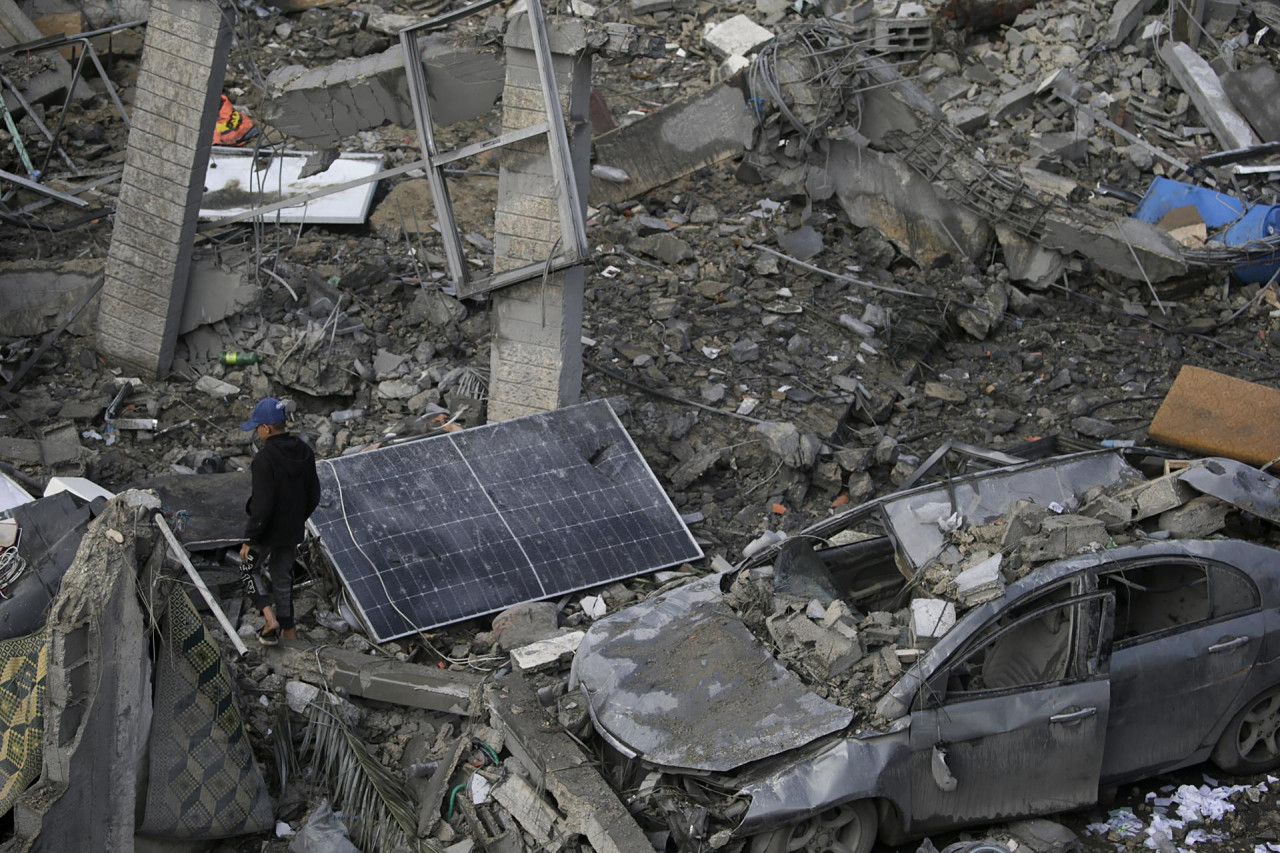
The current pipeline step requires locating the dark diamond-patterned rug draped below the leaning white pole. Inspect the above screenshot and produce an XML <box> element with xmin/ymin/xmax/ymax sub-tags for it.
<box><xmin>138</xmin><ymin>584</ymin><xmax>275</xmax><ymax>839</ymax></box>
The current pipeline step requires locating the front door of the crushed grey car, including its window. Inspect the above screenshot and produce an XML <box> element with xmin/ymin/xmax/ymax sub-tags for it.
<box><xmin>910</xmin><ymin>584</ymin><xmax>1112</xmax><ymax>833</ymax></box>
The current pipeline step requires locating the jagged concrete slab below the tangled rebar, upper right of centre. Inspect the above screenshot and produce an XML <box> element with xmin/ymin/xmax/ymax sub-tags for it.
<box><xmin>827</xmin><ymin>140</ymin><xmax>992</xmax><ymax>266</ymax></box>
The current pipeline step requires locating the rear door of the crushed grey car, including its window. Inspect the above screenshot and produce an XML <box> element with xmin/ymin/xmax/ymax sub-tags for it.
<box><xmin>1098</xmin><ymin>557</ymin><xmax>1263</xmax><ymax>785</ymax></box>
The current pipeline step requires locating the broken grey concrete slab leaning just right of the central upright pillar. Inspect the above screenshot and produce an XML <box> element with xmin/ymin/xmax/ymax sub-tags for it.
<box><xmin>590</xmin><ymin>85</ymin><xmax>755</xmax><ymax>205</ymax></box>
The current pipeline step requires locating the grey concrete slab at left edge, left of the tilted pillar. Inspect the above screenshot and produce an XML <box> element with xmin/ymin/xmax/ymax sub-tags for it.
<box><xmin>0</xmin><ymin>259</ymin><xmax>102</xmax><ymax>338</ymax></box>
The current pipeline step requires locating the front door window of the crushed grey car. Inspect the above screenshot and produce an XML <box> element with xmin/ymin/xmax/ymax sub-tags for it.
<box><xmin>946</xmin><ymin>593</ymin><xmax>1102</xmax><ymax>702</ymax></box>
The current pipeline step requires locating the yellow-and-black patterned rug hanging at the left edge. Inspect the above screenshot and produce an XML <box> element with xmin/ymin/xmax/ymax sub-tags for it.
<box><xmin>0</xmin><ymin>631</ymin><xmax>49</xmax><ymax>815</ymax></box>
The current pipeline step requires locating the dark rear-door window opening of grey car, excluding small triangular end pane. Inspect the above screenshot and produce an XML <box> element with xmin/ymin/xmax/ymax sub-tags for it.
<box><xmin>1098</xmin><ymin>562</ymin><xmax>1210</xmax><ymax>646</ymax></box>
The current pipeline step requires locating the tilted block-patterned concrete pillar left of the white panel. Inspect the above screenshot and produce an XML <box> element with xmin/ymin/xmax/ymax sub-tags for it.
<box><xmin>97</xmin><ymin>0</ymin><xmax>230</xmax><ymax>377</ymax></box>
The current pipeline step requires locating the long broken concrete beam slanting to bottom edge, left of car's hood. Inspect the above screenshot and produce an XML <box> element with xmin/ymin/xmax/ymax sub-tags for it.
<box><xmin>485</xmin><ymin>675</ymin><xmax>653</xmax><ymax>853</ymax></box>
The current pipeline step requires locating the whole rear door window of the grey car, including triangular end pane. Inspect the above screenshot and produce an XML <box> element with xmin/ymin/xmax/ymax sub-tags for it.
<box><xmin>1098</xmin><ymin>561</ymin><xmax>1258</xmax><ymax>648</ymax></box>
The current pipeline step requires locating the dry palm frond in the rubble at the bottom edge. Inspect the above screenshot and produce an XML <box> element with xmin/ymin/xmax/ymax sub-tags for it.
<box><xmin>302</xmin><ymin>690</ymin><xmax>440</xmax><ymax>853</ymax></box>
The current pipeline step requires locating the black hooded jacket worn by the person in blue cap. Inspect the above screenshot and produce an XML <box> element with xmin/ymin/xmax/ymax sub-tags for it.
<box><xmin>244</xmin><ymin>433</ymin><xmax>320</xmax><ymax>547</ymax></box>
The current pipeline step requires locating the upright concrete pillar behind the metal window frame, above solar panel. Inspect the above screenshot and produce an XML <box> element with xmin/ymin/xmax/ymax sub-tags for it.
<box><xmin>488</xmin><ymin>18</ymin><xmax>591</xmax><ymax>421</ymax></box>
